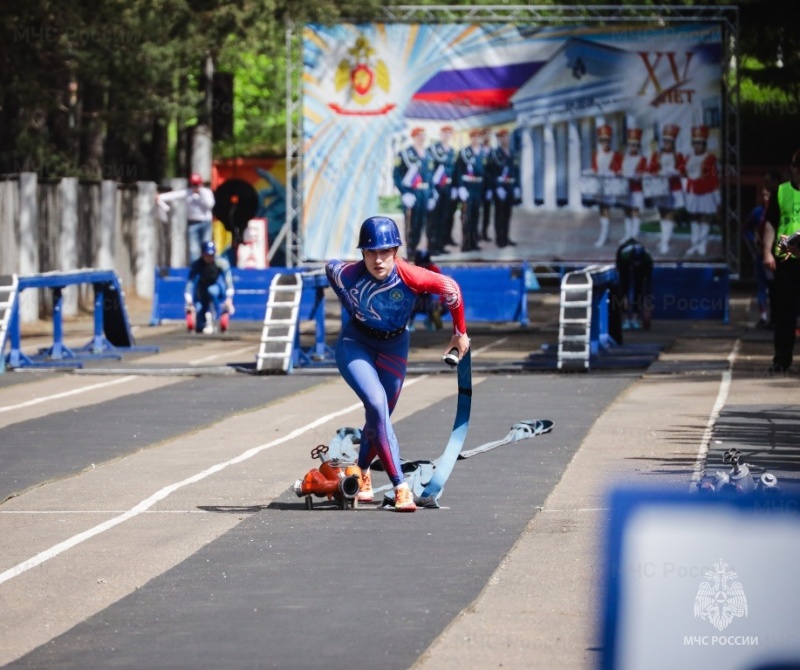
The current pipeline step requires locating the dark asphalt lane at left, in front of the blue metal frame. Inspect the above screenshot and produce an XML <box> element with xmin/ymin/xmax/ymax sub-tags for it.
<box><xmin>0</xmin><ymin>375</ymin><xmax>320</xmax><ymax>501</ymax></box>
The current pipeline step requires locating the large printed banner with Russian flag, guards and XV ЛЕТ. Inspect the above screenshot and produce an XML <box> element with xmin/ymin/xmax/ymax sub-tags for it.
<box><xmin>301</xmin><ymin>23</ymin><xmax>723</xmax><ymax>260</ymax></box>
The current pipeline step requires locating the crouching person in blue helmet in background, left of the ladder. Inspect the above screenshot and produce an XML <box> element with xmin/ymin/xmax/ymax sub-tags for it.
<box><xmin>183</xmin><ymin>242</ymin><xmax>235</xmax><ymax>335</ymax></box>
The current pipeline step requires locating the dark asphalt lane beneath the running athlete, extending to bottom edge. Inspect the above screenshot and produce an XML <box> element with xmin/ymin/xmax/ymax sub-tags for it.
<box><xmin>5</xmin><ymin>375</ymin><xmax>635</xmax><ymax>670</ymax></box>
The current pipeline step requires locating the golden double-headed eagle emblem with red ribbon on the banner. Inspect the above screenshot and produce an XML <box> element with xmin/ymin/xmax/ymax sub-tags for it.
<box><xmin>328</xmin><ymin>35</ymin><xmax>396</xmax><ymax>116</ymax></box>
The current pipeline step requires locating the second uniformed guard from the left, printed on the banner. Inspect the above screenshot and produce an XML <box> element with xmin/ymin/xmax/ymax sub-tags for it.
<box><xmin>428</xmin><ymin>126</ymin><xmax>458</xmax><ymax>255</ymax></box>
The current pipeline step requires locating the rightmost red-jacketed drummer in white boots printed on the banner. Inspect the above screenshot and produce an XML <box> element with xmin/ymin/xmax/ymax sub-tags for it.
<box><xmin>686</xmin><ymin>126</ymin><xmax>720</xmax><ymax>256</ymax></box>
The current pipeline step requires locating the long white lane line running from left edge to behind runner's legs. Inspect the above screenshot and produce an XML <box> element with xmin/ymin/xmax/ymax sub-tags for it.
<box><xmin>0</xmin><ymin>375</ymin><xmax>428</xmax><ymax>584</ymax></box>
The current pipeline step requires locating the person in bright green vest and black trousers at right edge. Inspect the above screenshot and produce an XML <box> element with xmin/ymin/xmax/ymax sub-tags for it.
<box><xmin>763</xmin><ymin>149</ymin><xmax>800</xmax><ymax>373</ymax></box>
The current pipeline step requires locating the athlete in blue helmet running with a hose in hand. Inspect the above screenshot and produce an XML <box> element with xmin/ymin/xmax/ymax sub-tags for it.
<box><xmin>325</xmin><ymin>216</ymin><xmax>469</xmax><ymax>512</ymax></box>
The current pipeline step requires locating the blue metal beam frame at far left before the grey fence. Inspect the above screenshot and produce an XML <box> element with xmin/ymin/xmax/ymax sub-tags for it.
<box><xmin>6</xmin><ymin>269</ymin><xmax>158</xmax><ymax>368</ymax></box>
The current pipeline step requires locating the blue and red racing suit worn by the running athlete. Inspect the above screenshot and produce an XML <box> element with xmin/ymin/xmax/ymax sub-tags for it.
<box><xmin>325</xmin><ymin>258</ymin><xmax>467</xmax><ymax>486</ymax></box>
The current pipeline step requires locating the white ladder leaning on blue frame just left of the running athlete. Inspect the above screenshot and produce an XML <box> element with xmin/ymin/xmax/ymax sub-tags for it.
<box><xmin>256</xmin><ymin>273</ymin><xmax>303</xmax><ymax>374</ymax></box>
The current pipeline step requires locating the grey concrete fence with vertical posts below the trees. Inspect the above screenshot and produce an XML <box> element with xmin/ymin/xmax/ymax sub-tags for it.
<box><xmin>0</xmin><ymin>173</ymin><xmax>186</xmax><ymax>322</ymax></box>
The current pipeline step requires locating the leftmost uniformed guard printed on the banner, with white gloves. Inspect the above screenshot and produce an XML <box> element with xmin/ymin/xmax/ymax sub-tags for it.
<box><xmin>393</xmin><ymin>128</ymin><xmax>436</xmax><ymax>258</ymax></box>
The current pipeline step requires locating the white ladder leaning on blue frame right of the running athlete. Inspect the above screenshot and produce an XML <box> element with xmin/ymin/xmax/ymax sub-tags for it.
<box><xmin>558</xmin><ymin>268</ymin><xmax>592</xmax><ymax>370</ymax></box>
